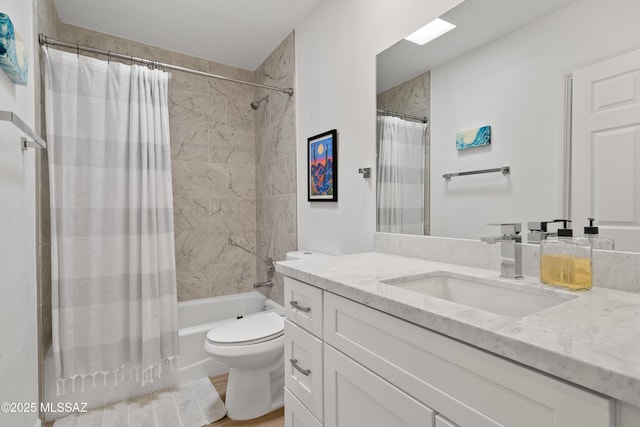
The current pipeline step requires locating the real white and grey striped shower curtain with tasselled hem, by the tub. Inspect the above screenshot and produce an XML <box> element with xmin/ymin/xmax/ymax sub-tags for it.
<box><xmin>43</xmin><ymin>48</ymin><xmax>178</xmax><ymax>392</ymax></box>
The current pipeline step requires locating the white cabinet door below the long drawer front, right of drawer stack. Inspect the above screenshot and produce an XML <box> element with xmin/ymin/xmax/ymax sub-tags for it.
<box><xmin>324</xmin><ymin>344</ymin><xmax>435</xmax><ymax>427</ymax></box>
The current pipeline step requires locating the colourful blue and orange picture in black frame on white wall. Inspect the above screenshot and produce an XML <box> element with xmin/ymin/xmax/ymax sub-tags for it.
<box><xmin>307</xmin><ymin>129</ymin><xmax>338</xmax><ymax>202</ymax></box>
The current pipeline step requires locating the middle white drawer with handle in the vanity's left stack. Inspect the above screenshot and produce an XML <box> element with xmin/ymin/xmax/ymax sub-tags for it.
<box><xmin>284</xmin><ymin>320</ymin><xmax>323</xmax><ymax>421</ymax></box>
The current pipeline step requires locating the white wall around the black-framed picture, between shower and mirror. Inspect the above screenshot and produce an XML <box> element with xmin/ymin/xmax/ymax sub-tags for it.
<box><xmin>296</xmin><ymin>0</ymin><xmax>461</xmax><ymax>254</ymax></box>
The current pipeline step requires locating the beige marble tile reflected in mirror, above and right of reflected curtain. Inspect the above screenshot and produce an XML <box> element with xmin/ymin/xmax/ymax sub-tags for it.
<box><xmin>376</xmin><ymin>71</ymin><xmax>431</xmax><ymax>235</ymax></box>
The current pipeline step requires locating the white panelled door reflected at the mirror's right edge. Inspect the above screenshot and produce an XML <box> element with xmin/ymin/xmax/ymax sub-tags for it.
<box><xmin>571</xmin><ymin>50</ymin><xmax>640</xmax><ymax>251</ymax></box>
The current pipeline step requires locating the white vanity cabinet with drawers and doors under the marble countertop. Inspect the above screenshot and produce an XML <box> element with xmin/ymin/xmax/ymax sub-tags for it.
<box><xmin>285</xmin><ymin>278</ymin><xmax>616</xmax><ymax>427</ymax></box>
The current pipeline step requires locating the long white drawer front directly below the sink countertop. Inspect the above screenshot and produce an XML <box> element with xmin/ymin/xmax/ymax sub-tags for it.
<box><xmin>324</xmin><ymin>292</ymin><xmax>612</xmax><ymax>427</ymax></box>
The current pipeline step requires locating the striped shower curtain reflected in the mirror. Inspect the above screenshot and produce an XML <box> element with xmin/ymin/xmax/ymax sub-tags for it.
<box><xmin>376</xmin><ymin>116</ymin><xmax>427</xmax><ymax>235</ymax></box>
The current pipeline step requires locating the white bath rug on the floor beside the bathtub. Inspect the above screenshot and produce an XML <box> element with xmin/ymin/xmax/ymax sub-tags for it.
<box><xmin>53</xmin><ymin>378</ymin><xmax>227</xmax><ymax>427</ymax></box>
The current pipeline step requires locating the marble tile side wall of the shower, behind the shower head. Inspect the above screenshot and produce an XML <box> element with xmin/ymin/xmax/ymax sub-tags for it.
<box><xmin>255</xmin><ymin>33</ymin><xmax>297</xmax><ymax>304</ymax></box>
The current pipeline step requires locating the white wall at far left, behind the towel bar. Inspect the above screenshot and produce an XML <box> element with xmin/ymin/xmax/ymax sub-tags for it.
<box><xmin>0</xmin><ymin>0</ymin><xmax>38</xmax><ymax>427</ymax></box>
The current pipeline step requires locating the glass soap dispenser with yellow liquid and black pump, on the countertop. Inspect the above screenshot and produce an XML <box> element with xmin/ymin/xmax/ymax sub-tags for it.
<box><xmin>540</xmin><ymin>220</ymin><xmax>592</xmax><ymax>290</ymax></box>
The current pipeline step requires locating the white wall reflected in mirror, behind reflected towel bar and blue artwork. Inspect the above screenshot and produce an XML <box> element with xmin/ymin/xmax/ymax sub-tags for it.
<box><xmin>431</xmin><ymin>0</ymin><xmax>640</xmax><ymax>238</ymax></box>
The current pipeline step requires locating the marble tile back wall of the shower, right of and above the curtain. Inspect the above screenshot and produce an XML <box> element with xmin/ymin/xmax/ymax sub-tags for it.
<box><xmin>43</xmin><ymin>24</ymin><xmax>256</xmax><ymax>301</ymax></box>
